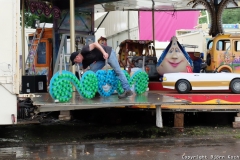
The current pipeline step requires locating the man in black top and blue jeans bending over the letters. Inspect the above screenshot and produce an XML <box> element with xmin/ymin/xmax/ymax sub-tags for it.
<box><xmin>70</xmin><ymin>42</ymin><xmax>133</xmax><ymax>98</ymax></box>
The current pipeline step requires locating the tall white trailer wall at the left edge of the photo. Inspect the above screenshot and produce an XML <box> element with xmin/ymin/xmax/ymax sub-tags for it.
<box><xmin>0</xmin><ymin>0</ymin><xmax>21</xmax><ymax>125</ymax></box>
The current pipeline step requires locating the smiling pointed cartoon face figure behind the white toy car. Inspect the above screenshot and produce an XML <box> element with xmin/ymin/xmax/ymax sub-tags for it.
<box><xmin>157</xmin><ymin>36</ymin><xmax>190</xmax><ymax>75</ymax></box>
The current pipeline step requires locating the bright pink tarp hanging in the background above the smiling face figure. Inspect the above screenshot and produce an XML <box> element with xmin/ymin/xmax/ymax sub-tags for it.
<box><xmin>139</xmin><ymin>11</ymin><xmax>200</xmax><ymax>42</ymax></box>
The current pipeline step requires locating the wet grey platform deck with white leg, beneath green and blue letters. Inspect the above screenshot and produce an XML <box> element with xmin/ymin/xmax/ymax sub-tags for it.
<box><xmin>32</xmin><ymin>92</ymin><xmax>189</xmax><ymax>128</ymax></box>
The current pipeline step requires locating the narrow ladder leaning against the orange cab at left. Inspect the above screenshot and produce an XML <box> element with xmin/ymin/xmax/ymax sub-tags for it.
<box><xmin>26</xmin><ymin>23</ymin><xmax>45</xmax><ymax>75</ymax></box>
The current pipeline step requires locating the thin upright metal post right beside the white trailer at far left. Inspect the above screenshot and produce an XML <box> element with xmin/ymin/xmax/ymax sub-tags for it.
<box><xmin>22</xmin><ymin>0</ymin><xmax>25</xmax><ymax>75</ymax></box>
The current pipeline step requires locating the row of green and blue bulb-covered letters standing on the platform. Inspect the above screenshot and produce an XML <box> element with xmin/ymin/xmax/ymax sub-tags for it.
<box><xmin>49</xmin><ymin>70</ymin><xmax>149</xmax><ymax>102</ymax></box>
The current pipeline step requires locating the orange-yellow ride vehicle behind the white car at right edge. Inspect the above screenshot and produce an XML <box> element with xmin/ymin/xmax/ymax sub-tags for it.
<box><xmin>206</xmin><ymin>34</ymin><xmax>240</xmax><ymax>73</ymax></box>
